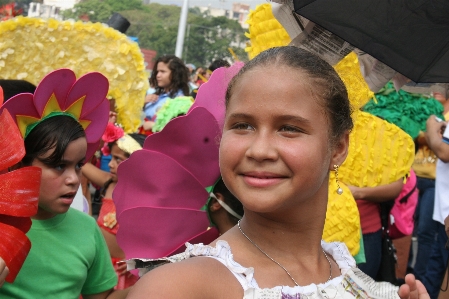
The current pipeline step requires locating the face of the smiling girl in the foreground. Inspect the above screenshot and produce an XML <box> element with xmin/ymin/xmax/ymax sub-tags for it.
<box><xmin>220</xmin><ymin>66</ymin><xmax>344</xmax><ymax>213</ymax></box>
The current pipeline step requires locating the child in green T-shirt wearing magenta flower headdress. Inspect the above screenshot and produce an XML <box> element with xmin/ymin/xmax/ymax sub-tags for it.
<box><xmin>0</xmin><ymin>69</ymin><xmax>127</xmax><ymax>299</ymax></box>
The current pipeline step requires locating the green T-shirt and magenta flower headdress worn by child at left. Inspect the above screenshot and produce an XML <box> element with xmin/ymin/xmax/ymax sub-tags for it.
<box><xmin>0</xmin><ymin>69</ymin><xmax>117</xmax><ymax>298</ymax></box>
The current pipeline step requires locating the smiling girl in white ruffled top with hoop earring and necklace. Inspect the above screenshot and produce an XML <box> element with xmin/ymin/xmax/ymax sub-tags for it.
<box><xmin>129</xmin><ymin>47</ymin><xmax>428</xmax><ymax>299</ymax></box>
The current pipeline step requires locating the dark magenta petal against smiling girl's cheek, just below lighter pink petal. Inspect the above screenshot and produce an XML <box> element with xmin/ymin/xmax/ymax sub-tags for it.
<box><xmin>144</xmin><ymin>107</ymin><xmax>221</xmax><ymax>187</ymax></box>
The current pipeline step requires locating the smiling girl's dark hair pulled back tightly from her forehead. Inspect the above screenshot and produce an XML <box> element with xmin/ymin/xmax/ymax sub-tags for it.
<box><xmin>226</xmin><ymin>46</ymin><xmax>353</xmax><ymax>142</ymax></box>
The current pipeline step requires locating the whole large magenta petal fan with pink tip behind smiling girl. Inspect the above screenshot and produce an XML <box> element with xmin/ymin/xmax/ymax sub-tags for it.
<box><xmin>113</xmin><ymin>63</ymin><xmax>243</xmax><ymax>259</ymax></box>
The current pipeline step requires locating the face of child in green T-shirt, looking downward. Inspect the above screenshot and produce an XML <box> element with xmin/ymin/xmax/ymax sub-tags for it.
<box><xmin>31</xmin><ymin>137</ymin><xmax>87</xmax><ymax>220</ymax></box>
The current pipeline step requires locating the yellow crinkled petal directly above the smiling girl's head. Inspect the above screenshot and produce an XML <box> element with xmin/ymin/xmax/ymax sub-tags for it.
<box><xmin>245</xmin><ymin>3</ymin><xmax>291</xmax><ymax>59</ymax></box>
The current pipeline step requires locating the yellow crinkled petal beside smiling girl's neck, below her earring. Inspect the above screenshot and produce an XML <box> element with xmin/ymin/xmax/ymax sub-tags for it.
<box><xmin>322</xmin><ymin>171</ymin><xmax>361</xmax><ymax>256</ymax></box>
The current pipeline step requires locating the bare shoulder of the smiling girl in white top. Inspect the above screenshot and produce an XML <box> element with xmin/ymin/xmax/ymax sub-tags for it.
<box><xmin>127</xmin><ymin>257</ymin><xmax>243</xmax><ymax>299</ymax></box>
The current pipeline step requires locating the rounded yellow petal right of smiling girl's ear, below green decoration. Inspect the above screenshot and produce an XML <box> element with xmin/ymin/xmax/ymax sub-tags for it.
<box><xmin>339</xmin><ymin>111</ymin><xmax>415</xmax><ymax>187</ymax></box>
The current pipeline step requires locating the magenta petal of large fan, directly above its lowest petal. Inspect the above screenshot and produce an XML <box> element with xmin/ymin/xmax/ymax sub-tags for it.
<box><xmin>113</xmin><ymin>150</ymin><xmax>209</xmax><ymax>214</ymax></box>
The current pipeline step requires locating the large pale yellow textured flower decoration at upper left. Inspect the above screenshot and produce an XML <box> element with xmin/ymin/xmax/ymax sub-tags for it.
<box><xmin>0</xmin><ymin>16</ymin><xmax>149</xmax><ymax>133</ymax></box>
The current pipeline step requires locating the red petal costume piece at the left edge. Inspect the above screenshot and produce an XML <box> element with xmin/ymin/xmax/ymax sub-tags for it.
<box><xmin>0</xmin><ymin>87</ymin><xmax>41</xmax><ymax>283</ymax></box>
